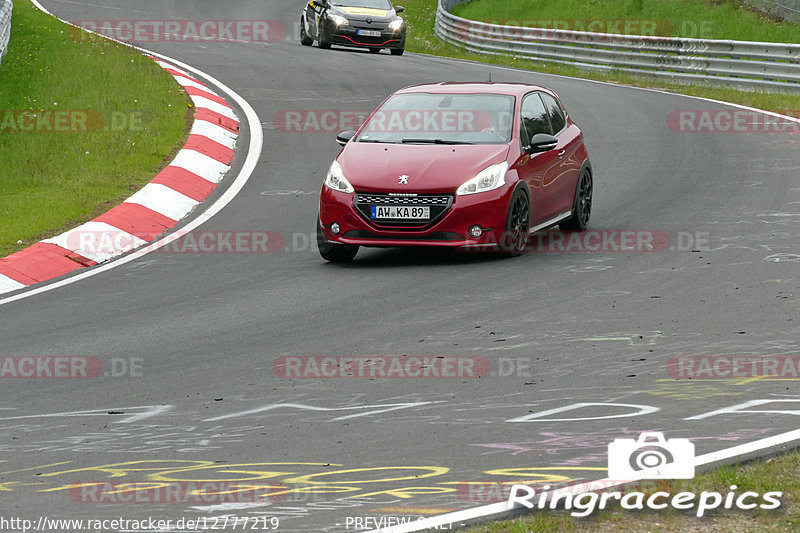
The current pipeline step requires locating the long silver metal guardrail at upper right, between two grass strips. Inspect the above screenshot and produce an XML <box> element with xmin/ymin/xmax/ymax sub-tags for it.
<box><xmin>436</xmin><ymin>0</ymin><xmax>800</xmax><ymax>93</ymax></box>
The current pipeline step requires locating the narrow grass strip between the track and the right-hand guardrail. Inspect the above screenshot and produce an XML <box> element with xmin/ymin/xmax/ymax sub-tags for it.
<box><xmin>400</xmin><ymin>0</ymin><xmax>800</xmax><ymax>116</ymax></box>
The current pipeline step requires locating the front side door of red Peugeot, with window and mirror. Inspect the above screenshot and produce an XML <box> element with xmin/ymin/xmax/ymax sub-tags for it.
<box><xmin>514</xmin><ymin>92</ymin><xmax>560</xmax><ymax>224</ymax></box>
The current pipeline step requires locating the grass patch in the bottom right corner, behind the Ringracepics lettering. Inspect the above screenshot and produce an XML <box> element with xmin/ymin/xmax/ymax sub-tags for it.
<box><xmin>460</xmin><ymin>451</ymin><xmax>800</xmax><ymax>533</ymax></box>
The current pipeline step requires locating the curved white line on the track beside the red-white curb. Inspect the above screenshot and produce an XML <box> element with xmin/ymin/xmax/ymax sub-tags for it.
<box><xmin>0</xmin><ymin>0</ymin><xmax>264</xmax><ymax>305</ymax></box>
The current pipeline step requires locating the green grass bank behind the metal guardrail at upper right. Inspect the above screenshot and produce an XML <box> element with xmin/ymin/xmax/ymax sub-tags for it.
<box><xmin>453</xmin><ymin>0</ymin><xmax>800</xmax><ymax>43</ymax></box>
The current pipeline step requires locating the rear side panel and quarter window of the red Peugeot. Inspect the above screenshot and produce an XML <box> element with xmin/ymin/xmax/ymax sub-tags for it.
<box><xmin>540</xmin><ymin>92</ymin><xmax>583</xmax><ymax>216</ymax></box>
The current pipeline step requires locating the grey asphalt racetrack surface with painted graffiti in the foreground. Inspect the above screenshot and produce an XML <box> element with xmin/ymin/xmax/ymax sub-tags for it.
<box><xmin>0</xmin><ymin>0</ymin><xmax>800</xmax><ymax>532</ymax></box>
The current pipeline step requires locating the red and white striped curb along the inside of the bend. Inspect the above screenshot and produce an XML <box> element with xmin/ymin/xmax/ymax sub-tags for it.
<box><xmin>0</xmin><ymin>56</ymin><xmax>239</xmax><ymax>294</ymax></box>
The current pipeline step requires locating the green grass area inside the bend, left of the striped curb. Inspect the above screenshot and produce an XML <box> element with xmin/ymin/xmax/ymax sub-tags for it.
<box><xmin>0</xmin><ymin>0</ymin><xmax>190</xmax><ymax>257</ymax></box>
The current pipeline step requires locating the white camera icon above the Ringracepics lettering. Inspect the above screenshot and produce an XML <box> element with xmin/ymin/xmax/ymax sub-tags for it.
<box><xmin>608</xmin><ymin>432</ymin><xmax>694</xmax><ymax>479</ymax></box>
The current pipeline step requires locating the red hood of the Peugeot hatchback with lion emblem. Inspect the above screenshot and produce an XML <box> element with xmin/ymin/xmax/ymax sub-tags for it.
<box><xmin>337</xmin><ymin>142</ymin><xmax>509</xmax><ymax>194</ymax></box>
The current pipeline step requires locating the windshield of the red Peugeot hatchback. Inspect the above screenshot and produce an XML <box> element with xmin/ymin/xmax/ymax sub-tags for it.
<box><xmin>356</xmin><ymin>93</ymin><xmax>514</xmax><ymax>144</ymax></box>
